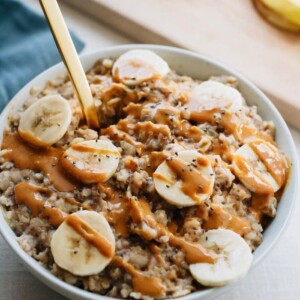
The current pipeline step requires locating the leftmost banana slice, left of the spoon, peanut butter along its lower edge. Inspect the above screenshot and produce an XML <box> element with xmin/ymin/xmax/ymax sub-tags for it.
<box><xmin>19</xmin><ymin>95</ymin><xmax>72</xmax><ymax>147</ymax></box>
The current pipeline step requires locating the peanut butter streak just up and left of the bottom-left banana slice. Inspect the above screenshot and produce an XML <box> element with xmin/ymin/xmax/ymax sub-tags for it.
<box><xmin>14</xmin><ymin>182</ymin><xmax>66</xmax><ymax>227</ymax></box>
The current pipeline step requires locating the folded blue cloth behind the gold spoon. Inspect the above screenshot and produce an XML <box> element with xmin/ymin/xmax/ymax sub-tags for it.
<box><xmin>0</xmin><ymin>0</ymin><xmax>84</xmax><ymax>111</ymax></box>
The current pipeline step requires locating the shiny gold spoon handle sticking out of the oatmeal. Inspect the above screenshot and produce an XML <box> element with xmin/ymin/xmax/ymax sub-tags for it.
<box><xmin>40</xmin><ymin>0</ymin><xmax>99</xmax><ymax>129</ymax></box>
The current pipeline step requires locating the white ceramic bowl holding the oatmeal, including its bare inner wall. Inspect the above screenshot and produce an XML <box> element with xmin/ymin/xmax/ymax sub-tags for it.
<box><xmin>0</xmin><ymin>45</ymin><xmax>299</xmax><ymax>300</ymax></box>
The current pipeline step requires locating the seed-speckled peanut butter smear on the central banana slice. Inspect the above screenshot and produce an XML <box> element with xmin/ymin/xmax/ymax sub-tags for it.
<box><xmin>166</xmin><ymin>157</ymin><xmax>211</xmax><ymax>202</ymax></box>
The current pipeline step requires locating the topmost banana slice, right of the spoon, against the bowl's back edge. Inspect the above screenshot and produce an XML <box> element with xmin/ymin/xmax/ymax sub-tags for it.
<box><xmin>112</xmin><ymin>49</ymin><xmax>170</xmax><ymax>85</ymax></box>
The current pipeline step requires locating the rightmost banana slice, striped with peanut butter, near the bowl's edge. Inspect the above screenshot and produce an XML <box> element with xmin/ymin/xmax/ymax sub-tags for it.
<box><xmin>232</xmin><ymin>141</ymin><xmax>288</xmax><ymax>194</ymax></box>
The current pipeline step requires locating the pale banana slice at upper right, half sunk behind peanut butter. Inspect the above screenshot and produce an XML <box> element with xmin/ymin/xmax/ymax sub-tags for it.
<box><xmin>188</xmin><ymin>80</ymin><xmax>245</xmax><ymax>112</ymax></box>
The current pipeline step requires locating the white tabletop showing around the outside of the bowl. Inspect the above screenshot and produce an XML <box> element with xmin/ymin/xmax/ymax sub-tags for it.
<box><xmin>0</xmin><ymin>0</ymin><xmax>300</xmax><ymax>300</ymax></box>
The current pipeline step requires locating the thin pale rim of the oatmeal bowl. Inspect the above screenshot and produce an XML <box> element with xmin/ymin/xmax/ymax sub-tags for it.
<box><xmin>0</xmin><ymin>44</ymin><xmax>299</xmax><ymax>300</ymax></box>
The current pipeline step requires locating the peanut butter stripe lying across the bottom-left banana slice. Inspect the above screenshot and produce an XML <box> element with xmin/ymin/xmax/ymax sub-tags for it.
<box><xmin>65</xmin><ymin>214</ymin><xmax>115</xmax><ymax>258</ymax></box>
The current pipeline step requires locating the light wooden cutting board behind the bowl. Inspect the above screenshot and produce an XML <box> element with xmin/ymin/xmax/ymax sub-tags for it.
<box><xmin>64</xmin><ymin>0</ymin><xmax>300</xmax><ymax>129</ymax></box>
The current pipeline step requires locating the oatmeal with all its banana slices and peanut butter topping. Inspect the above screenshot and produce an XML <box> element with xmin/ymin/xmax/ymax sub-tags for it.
<box><xmin>0</xmin><ymin>50</ymin><xmax>289</xmax><ymax>299</ymax></box>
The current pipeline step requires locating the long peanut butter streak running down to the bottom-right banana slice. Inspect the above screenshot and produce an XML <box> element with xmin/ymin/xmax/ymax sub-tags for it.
<box><xmin>130</xmin><ymin>199</ymin><xmax>215</xmax><ymax>264</ymax></box>
